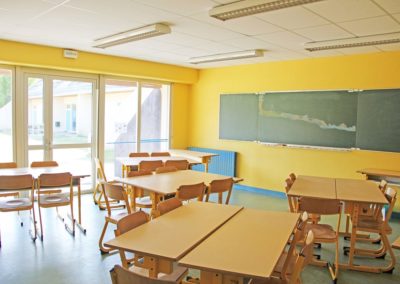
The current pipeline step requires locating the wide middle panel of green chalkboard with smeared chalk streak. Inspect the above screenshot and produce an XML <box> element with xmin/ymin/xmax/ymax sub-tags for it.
<box><xmin>259</xmin><ymin>91</ymin><xmax>357</xmax><ymax>148</ymax></box>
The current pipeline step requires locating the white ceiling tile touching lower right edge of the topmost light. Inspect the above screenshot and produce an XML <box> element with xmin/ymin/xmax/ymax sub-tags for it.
<box><xmin>256</xmin><ymin>7</ymin><xmax>329</xmax><ymax>29</ymax></box>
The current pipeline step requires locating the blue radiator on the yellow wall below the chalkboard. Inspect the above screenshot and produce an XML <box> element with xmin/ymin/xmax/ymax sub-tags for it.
<box><xmin>188</xmin><ymin>147</ymin><xmax>236</xmax><ymax>176</ymax></box>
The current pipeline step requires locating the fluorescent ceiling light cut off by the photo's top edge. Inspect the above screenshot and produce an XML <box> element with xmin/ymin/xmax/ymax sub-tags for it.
<box><xmin>209</xmin><ymin>0</ymin><xmax>322</xmax><ymax>21</ymax></box>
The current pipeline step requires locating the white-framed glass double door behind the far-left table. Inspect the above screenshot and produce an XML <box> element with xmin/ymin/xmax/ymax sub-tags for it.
<box><xmin>25</xmin><ymin>74</ymin><xmax>96</xmax><ymax>186</ymax></box>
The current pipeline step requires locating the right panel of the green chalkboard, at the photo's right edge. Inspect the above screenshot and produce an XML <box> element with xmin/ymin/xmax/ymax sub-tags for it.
<box><xmin>357</xmin><ymin>89</ymin><xmax>400</xmax><ymax>152</ymax></box>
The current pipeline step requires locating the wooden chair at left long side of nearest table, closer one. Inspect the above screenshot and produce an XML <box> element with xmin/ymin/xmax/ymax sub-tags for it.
<box><xmin>115</xmin><ymin>211</ymin><xmax>150</xmax><ymax>268</ymax></box>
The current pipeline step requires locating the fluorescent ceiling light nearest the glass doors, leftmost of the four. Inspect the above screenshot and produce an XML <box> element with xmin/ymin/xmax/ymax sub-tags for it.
<box><xmin>93</xmin><ymin>24</ymin><xmax>171</xmax><ymax>48</ymax></box>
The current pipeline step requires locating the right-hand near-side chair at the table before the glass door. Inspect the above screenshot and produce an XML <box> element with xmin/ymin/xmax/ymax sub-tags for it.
<box><xmin>37</xmin><ymin>172</ymin><xmax>75</xmax><ymax>241</ymax></box>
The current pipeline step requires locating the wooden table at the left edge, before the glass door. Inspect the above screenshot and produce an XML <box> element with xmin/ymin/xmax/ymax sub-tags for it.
<box><xmin>0</xmin><ymin>166</ymin><xmax>90</xmax><ymax>234</ymax></box>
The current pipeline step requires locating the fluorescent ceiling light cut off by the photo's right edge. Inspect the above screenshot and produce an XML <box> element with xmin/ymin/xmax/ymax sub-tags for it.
<box><xmin>304</xmin><ymin>33</ymin><xmax>400</xmax><ymax>52</ymax></box>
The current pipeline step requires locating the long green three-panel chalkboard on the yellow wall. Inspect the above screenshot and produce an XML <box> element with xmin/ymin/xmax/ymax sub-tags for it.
<box><xmin>220</xmin><ymin>89</ymin><xmax>400</xmax><ymax>152</ymax></box>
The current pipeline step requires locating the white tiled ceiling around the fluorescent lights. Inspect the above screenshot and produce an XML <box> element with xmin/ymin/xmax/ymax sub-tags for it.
<box><xmin>0</xmin><ymin>0</ymin><xmax>400</xmax><ymax>68</ymax></box>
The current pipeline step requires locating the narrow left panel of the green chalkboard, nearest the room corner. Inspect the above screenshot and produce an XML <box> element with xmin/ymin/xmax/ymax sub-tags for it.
<box><xmin>219</xmin><ymin>94</ymin><xmax>258</xmax><ymax>141</ymax></box>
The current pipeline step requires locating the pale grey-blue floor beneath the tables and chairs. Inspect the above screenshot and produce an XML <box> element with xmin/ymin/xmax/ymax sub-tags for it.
<box><xmin>0</xmin><ymin>190</ymin><xmax>400</xmax><ymax>284</ymax></box>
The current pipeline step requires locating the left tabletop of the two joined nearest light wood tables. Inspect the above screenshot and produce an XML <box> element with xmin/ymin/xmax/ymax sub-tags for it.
<box><xmin>105</xmin><ymin>202</ymin><xmax>243</xmax><ymax>260</ymax></box>
